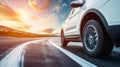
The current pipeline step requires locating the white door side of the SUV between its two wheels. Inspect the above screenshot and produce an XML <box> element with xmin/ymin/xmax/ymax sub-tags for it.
<box><xmin>65</xmin><ymin>7</ymin><xmax>80</xmax><ymax>35</ymax></box>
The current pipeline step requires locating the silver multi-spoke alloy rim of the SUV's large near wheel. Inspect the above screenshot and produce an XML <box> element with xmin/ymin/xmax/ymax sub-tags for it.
<box><xmin>84</xmin><ymin>25</ymin><xmax>98</xmax><ymax>51</ymax></box>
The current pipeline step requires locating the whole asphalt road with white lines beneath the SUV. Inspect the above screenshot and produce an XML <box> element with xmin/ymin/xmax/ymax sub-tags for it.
<box><xmin>0</xmin><ymin>37</ymin><xmax>120</xmax><ymax>67</ymax></box>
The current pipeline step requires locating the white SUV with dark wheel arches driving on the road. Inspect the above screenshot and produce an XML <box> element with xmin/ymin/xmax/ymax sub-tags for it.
<box><xmin>61</xmin><ymin>0</ymin><xmax>120</xmax><ymax>58</ymax></box>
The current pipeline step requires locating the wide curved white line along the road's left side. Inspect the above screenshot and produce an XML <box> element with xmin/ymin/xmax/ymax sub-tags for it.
<box><xmin>0</xmin><ymin>40</ymin><xmax>41</xmax><ymax>67</ymax></box>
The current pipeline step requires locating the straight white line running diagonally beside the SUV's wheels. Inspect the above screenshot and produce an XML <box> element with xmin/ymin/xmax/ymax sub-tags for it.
<box><xmin>49</xmin><ymin>40</ymin><xmax>97</xmax><ymax>67</ymax></box>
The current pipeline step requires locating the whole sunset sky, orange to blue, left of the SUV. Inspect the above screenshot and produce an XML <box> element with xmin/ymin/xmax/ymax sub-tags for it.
<box><xmin>0</xmin><ymin>0</ymin><xmax>72</xmax><ymax>33</ymax></box>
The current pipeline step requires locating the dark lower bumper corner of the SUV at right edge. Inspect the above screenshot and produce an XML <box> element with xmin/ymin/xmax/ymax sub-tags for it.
<box><xmin>109</xmin><ymin>25</ymin><xmax>120</xmax><ymax>46</ymax></box>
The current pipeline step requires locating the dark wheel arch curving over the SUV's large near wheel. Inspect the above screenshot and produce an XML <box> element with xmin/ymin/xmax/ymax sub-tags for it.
<box><xmin>80</xmin><ymin>9</ymin><xmax>111</xmax><ymax>40</ymax></box>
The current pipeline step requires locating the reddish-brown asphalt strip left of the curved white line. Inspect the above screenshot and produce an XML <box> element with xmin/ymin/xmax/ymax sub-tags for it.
<box><xmin>0</xmin><ymin>36</ymin><xmax>38</xmax><ymax>60</ymax></box>
